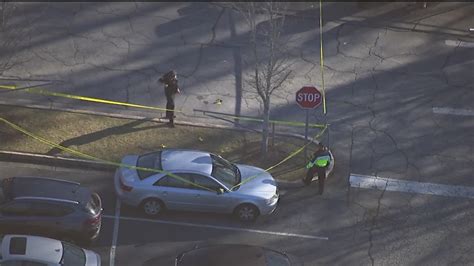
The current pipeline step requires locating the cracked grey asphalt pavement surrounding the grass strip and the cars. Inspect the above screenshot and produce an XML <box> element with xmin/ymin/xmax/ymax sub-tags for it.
<box><xmin>0</xmin><ymin>2</ymin><xmax>474</xmax><ymax>265</ymax></box>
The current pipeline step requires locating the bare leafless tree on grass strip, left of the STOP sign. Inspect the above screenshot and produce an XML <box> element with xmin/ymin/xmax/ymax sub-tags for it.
<box><xmin>233</xmin><ymin>2</ymin><xmax>291</xmax><ymax>158</ymax></box>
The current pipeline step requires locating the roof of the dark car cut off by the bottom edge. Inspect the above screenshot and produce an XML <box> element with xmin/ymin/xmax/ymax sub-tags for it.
<box><xmin>178</xmin><ymin>244</ymin><xmax>290</xmax><ymax>266</ymax></box>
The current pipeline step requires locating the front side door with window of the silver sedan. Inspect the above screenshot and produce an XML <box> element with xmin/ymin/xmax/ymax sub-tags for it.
<box><xmin>190</xmin><ymin>174</ymin><xmax>233</xmax><ymax>212</ymax></box>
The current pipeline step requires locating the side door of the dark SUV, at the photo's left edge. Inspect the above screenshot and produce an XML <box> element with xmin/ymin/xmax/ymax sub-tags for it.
<box><xmin>0</xmin><ymin>201</ymin><xmax>37</xmax><ymax>234</ymax></box>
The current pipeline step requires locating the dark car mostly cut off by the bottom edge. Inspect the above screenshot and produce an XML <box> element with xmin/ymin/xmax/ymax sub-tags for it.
<box><xmin>175</xmin><ymin>244</ymin><xmax>303</xmax><ymax>266</ymax></box>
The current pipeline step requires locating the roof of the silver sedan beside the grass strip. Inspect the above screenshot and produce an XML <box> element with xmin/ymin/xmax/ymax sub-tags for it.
<box><xmin>161</xmin><ymin>149</ymin><xmax>212</xmax><ymax>175</ymax></box>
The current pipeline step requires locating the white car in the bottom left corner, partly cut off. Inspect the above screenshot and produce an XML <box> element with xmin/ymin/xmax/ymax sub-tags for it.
<box><xmin>0</xmin><ymin>235</ymin><xmax>101</xmax><ymax>266</ymax></box>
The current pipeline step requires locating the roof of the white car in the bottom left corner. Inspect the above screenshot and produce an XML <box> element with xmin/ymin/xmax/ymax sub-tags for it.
<box><xmin>1</xmin><ymin>235</ymin><xmax>63</xmax><ymax>263</ymax></box>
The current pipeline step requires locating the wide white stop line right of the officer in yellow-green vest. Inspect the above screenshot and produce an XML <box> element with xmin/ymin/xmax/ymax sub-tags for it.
<box><xmin>349</xmin><ymin>174</ymin><xmax>474</xmax><ymax>199</ymax></box>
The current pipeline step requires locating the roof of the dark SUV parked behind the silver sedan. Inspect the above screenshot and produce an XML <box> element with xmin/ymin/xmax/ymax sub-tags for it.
<box><xmin>3</xmin><ymin>176</ymin><xmax>91</xmax><ymax>204</ymax></box>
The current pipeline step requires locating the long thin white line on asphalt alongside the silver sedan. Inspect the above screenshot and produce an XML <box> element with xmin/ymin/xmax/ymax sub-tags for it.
<box><xmin>102</xmin><ymin>215</ymin><xmax>329</xmax><ymax>240</ymax></box>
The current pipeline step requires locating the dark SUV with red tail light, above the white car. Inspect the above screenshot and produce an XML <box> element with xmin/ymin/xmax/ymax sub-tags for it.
<box><xmin>0</xmin><ymin>177</ymin><xmax>102</xmax><ymax>244</ymax></box>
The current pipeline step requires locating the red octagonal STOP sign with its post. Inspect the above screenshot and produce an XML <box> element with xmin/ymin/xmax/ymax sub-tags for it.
<box><xmin>296</xmin><ymin>86</ymin><xmax>322</xmax><ymax>161</ymax></box>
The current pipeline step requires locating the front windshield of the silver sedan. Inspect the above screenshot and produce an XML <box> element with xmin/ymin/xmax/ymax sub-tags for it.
<box><xmin>211</xmin><ymin>154</ymin><xmax>240</xmax><ymax>188</ymax></box>
